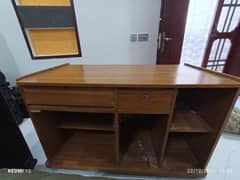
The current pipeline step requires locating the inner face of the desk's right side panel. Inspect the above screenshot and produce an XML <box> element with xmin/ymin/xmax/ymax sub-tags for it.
<box><xmin>181</xmin><ymin>88</ymin><xmax>239</xmax><ymax>168</ymax></box>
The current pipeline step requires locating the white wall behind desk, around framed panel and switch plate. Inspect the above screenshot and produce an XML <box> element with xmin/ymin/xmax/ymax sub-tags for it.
<box><xmin>0</xmin><ymin>0</ymin><xmax>161</xmax><ymax>75</ymax></box>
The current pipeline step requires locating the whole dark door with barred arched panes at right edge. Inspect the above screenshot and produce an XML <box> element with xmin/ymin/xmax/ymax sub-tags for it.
<box><xmin>202</xmin><ymin>0</ymin><xmax>240</xmax><ymax>76</ymax></box>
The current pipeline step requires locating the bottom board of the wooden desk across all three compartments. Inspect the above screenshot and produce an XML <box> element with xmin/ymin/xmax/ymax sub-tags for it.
<box><xmin>47</xmin><ymin>131</ymin><xmax>206</xmax><ymax>177</ymax></box>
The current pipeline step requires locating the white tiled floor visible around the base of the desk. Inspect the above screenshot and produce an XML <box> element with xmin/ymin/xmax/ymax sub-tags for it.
<box><xmin>20</xmin><ymin>99</ymin><xmax>240</xmax><ymax>180</ymax></box>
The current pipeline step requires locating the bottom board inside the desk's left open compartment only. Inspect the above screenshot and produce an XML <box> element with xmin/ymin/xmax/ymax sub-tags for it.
<box><xmin>47</xmin><ymin>131</ymin><xmax>116</xmax><ymax>167</ymax></box>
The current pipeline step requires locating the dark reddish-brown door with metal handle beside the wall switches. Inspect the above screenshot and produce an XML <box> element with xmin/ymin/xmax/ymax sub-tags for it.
<box><xmin>157</xmin><ymin>0</ymin><xmax>189</xmax><ymax>64</ymax></box>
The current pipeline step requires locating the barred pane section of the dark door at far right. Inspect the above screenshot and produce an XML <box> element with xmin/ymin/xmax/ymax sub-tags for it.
<box><xmin>203</xmin><ymin>0</ymin><xmax>240</xmax><ymax>72</ymax></box>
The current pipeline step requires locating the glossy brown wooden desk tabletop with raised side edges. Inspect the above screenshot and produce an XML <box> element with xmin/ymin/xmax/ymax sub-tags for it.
<box><xmin>17</xmin><ymin>64</ymin><xmax>240</xmax><ymax>88</ymax></box>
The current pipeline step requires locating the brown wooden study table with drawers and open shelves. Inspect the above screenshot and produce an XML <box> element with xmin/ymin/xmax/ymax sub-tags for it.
<box><xmin>17</xmin><ymin>64</ymin><xmax>240</xmax><ymax>177</ymax></box>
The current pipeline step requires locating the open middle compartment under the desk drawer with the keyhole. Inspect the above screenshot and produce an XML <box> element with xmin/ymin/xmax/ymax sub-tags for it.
<box><xmin>120</xmin><ymin>114</ymin><xmax>168</xmax><ymax>168</ymax></box>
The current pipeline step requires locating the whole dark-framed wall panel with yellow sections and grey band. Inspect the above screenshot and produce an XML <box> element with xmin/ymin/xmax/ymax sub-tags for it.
<box><xmin>12</xmin><ymin>0</ymin><xmax>81</xmax><ymax>59</ymax></box>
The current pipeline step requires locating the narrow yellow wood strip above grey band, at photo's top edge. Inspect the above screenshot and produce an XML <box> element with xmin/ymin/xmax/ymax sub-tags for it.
<box><xmin>19</xmin><ymin>0</ymin><xmax>71</xmax><ymax>6</ymax></box>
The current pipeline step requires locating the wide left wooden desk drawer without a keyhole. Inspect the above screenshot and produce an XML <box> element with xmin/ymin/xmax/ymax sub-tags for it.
<box><xmin>23</xmin><ymin>87</ymin><xmax>114</xmax><ymax>107</ymax></box>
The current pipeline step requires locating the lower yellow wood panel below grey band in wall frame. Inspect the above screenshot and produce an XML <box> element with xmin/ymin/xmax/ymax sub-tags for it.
<box><xmin>28</xmin><ymin>29</ymin><xmax>79</xmax><ymax>56</ymax></box>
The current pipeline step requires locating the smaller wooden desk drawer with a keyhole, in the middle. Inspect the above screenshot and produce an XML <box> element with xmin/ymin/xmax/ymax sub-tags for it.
<box><xmin>117</xmin><ymin>89</ymin><xmax>175</xmax><ymax>114</ymax></box>
